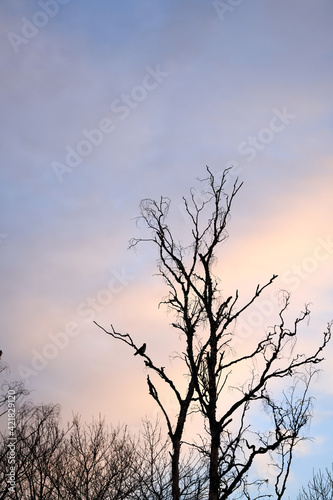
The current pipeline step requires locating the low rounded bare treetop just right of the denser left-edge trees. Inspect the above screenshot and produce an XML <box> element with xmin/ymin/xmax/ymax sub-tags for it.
<box><xmin>57</xmin><ymin>417</ymin><xmax>138</xmax><ymax>500</ymax></box>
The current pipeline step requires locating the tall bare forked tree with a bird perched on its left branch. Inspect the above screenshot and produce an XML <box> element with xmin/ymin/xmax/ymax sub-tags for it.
<box><xmin>96</xmin><ymin>167</ymin><xmax>331</xmax><ymax>500</ymax></box>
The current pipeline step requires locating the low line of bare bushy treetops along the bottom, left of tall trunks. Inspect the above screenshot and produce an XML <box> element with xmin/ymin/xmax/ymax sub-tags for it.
<box><xmin>0</xmin><ymin>402</ymin><xmax>207</xmax><ymax>500</ymax></box>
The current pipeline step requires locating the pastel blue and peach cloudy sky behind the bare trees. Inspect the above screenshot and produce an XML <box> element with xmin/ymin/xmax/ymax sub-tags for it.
<box><xmin>0</xmin><ymin>0</ymin><xmax>333</xmax><ymax>495</ymax></box>
